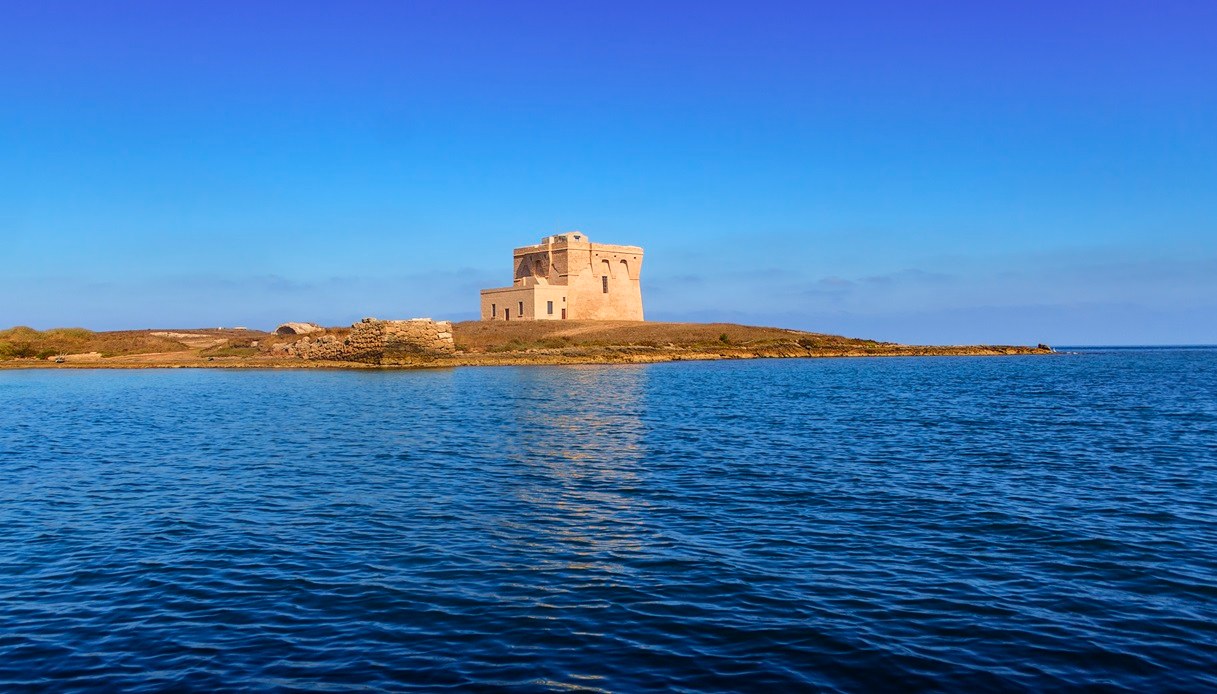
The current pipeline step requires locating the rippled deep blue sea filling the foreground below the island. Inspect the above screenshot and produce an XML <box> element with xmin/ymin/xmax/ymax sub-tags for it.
<box><xmin>0</xmin><ymin>348</ymin><xmax>1217</xmax><ymax>692</ymax></box>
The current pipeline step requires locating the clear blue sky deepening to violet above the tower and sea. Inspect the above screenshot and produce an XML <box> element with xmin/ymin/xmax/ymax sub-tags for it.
<box><xmin>0</xmin><ymin>0</ymin><xmax>1217</xmax><ymax>343</ymax></box>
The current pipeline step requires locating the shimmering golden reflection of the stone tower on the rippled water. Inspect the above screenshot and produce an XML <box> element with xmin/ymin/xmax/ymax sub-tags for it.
<box><xmin>491</xmin><ymin>365</ymin><xmax>650</xmax><ymax>692</ymax></box>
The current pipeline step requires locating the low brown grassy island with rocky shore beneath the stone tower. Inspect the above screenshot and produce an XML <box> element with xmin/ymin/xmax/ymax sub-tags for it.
<box><xmin>0</xmin><ymin>319</ymin><xmax>1053</xmax><ymax>369</ymax></box>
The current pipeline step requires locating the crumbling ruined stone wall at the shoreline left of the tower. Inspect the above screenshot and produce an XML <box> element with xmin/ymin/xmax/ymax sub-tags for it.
<box><xmin>271</xmin><ymin>318</ymin><xmax>456</xmax><ymax>364</ymax></box>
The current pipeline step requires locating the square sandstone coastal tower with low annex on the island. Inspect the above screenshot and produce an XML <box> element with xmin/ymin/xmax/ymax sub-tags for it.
<box><xmin>482</xmin><ymin>231</ymin><xmax>643</xmax><ymax>320</ymax></box>
